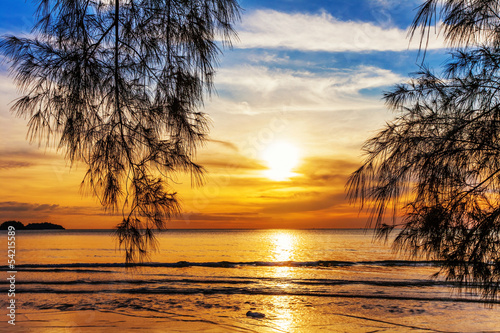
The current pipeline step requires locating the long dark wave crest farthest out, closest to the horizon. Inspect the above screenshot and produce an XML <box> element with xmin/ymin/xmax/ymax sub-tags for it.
<box><xmin>3</xmin><ymin>260</ymin><xmax>441</xmax><ymax>270</ymax></box>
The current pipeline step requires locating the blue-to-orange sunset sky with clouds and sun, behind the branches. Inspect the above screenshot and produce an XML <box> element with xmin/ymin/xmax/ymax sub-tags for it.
<box><xmin>0</xmin><ymin>0</ymin><xmax>446</xmax><ymax>229</ymax></box>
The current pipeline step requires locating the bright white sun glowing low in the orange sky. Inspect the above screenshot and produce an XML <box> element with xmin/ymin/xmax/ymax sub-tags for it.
<box><xmin>262</xmin><ymin>142</ymin><xmax>299</xmax><ymax>181</ymax></box>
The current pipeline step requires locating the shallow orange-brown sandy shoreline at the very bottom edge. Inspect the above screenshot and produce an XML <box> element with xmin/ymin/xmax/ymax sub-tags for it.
<box><xmin>2</xmin><ymin>303</ymin><xmax>500</xmax><ymax>333</ymax></box>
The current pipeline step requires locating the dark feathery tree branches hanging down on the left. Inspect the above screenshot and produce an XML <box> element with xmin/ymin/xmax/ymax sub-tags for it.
<box><xmin>0</xmin><ymin>0</ymin><xmax>239</xmax><ymax>263</ymax></box>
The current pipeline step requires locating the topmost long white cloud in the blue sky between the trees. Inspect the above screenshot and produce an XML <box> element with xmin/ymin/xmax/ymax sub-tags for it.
<box><xmin>234</xmin><ymin>10</ymin><xmax>444</xmax><ymax>52</ymax></box>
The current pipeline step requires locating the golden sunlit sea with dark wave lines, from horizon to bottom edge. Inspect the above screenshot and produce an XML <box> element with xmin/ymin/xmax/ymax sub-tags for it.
<box><xmin>0</xmin><ymin>230</ymin><xmax>500</xmax><ymax>332</ymax></box>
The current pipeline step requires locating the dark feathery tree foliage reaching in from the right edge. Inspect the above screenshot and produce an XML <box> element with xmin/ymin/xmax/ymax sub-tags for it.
<box><xmin>347</xmin><ymin>0</ymin><xmax>500</xmax><ymax>301</ymax></box>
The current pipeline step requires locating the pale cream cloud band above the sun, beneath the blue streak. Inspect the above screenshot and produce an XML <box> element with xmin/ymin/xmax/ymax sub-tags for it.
<box><xmin>209</xmin><ymin>65</ymin><xmax>404</xmax><ymax>114</ymax></box>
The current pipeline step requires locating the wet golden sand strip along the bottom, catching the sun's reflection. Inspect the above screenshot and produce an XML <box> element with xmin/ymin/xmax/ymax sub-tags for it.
<box><xmin>2</xmin><ymin>298</ymin><xmax>500</xmax><ymax>333</ymax></box>
